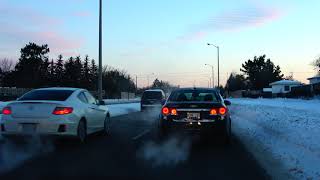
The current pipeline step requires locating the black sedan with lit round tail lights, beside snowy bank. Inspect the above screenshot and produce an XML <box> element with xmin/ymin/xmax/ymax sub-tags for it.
<box><xmin>159</xmin><ymin>88</ymin><xmax>231</xmax><ymax>142</ymax></box>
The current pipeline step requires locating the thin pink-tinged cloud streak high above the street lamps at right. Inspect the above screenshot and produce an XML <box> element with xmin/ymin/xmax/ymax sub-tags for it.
<box><xmin>176</xmin><ymin>1</ymin><xmax>285</xmax><ymax>42</ymax></box>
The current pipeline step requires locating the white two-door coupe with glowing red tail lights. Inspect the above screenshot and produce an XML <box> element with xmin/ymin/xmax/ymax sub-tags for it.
<box><xmin>0</xmin><ymin>88</ymin><xmax>110</xmax><ymax>142</ymax></box>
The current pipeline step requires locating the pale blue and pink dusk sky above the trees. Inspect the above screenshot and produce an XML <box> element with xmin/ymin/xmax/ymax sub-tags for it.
<box><xmin>0</xmin><ymin>0</ymin><xmax>320</xmax><ymax>87</ymax></box>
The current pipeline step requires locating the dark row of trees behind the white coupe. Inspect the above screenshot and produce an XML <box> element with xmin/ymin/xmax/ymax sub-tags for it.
<box><xmin>0</xmin><ymin>43</ymin><xmax>136</xmax><ymax>98</ymax></box>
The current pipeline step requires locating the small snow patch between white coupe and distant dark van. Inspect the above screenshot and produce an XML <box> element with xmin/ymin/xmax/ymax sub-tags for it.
<box><xmin>107</xmin><ymin>103</ymin><xmax>140</xmax><ymax>117</ymax></box>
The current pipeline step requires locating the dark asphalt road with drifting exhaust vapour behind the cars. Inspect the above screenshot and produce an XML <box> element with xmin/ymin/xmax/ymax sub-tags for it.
<box><xmin>0</xmin><ymin>112</ymin><xmax>268</xmax><ymax>180</ymax></box>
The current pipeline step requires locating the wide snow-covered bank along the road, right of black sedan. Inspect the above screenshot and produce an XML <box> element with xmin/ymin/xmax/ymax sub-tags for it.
<box><xmin>230</xmin><ymin>99</ymin><xmax>320</xmax><ymax>179</ymax></box>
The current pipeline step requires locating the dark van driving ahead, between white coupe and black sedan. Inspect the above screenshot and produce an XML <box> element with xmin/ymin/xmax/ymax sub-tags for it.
<box><xmin>141</xmin><ymin>89</ymin><xmax>166</xmax><ymax>111</ymax></box>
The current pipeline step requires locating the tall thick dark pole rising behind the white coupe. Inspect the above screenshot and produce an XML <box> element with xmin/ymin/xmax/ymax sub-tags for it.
<box><xmin>98</xmin><ymin>0</ymin><xmax>102</xmax><ymax>101</ymax></box>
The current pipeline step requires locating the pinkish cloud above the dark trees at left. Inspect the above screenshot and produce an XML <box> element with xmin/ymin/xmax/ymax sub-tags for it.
<box><xmin>0</xmin><ymin>4</ymin><xmax>84</xmax><ymax>56</ymax></box>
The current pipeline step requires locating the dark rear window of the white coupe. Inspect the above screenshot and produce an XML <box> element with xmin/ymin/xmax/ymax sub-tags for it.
<box><xmin>18</xmin><ymin>90</ymin><xmax>74</xmax><ymax>101</ymax></box>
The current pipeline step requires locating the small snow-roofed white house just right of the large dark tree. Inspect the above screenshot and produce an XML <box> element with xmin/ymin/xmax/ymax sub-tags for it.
<box><xmin>270</xmin><ymin>80</ymin><xmax>302</xmax><ymax>94</ymax></box>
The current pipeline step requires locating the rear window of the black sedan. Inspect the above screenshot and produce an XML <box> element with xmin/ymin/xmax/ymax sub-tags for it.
<box><xmin>169</xmin><ymin>90</ymin><xmax>220</xmax><ymax>102</ymax></box>
